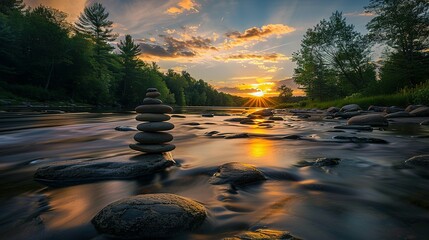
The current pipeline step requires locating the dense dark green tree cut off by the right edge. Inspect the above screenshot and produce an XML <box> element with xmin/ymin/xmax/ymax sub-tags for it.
<box><xmin>365</xmin><ymin>0</ymin><xmax>429</xmax><ymax>85</ymax></box>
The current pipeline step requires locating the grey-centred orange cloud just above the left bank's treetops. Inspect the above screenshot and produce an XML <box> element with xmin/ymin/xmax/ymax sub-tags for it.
<box><xmin>140</xmin><ymin>35</ymin><xmax>217</xmax><ymax>59</ymax></box>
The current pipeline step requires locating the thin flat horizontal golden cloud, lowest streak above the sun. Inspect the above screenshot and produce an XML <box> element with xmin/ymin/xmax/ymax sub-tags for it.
<box><xmin>214</xmin><ymin>53</ymin><xmax>290</xmax><ymax>62</ymax></box>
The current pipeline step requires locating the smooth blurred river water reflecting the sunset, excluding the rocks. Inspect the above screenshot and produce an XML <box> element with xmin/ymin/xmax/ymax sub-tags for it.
<box><xmin>0</xmin><ymin>108</ymin><xmax>429</xmax><ymax>240</ymax></box>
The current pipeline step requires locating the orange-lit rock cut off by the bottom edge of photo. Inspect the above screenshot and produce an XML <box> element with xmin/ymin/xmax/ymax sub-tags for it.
<box><xmin>223</xmin><ymin>229</ymin><xmax>300</xmax><ymax>240</ymax></box>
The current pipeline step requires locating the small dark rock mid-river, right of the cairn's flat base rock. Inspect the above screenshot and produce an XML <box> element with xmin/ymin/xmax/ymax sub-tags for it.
<box><xmin>210</xmin><ymin>162</ymin><xmax>266</xmax><ymax>185</ymax></box>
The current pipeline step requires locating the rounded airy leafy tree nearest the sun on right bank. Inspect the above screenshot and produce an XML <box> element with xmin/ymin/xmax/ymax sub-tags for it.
<box><xmin>293</xmin><ymin>12</ymin><xmax>375</xmax><ymax>100</ymax></box>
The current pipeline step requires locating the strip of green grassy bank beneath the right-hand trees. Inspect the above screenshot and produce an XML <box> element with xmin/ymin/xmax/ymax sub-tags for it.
<box><xmin>275</xmin><ymin>82</ymin><xmax>429</xmax><ymax>109</ymax></box>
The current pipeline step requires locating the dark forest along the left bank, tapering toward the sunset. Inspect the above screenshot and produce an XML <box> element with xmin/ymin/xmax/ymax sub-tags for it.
<box><xmin>0</xmin><ymin>0</ymin><xmax>246</xmax><ymax>107</ymax></box>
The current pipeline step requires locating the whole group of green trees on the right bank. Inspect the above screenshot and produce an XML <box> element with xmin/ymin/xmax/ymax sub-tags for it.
<box><xmin>293</xmin><ymin>0</ymin><xmax>429</xmax><ymax>101</ymax></box>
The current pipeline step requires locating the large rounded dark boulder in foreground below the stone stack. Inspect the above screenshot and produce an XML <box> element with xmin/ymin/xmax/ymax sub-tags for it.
<box><xmin>91</xmin><ymin>193</ymin><xmax>207</xmax><ymax>239</ymax></box>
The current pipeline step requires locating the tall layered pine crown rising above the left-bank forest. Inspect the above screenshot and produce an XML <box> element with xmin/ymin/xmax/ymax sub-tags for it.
<box><xmin>75</xmin><ymin>3</ymin><xmax>117</xmax><ymax>58</ymax></box>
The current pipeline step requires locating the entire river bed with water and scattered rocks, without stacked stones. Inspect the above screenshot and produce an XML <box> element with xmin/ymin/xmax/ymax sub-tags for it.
<box><xmin>0</xmin><ymin>106</ymin><xmax>429</xmax><ymax>239</ymax></box>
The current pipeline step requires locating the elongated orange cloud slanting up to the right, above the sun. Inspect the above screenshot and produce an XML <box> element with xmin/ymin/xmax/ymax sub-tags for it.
<box><xmin>225</xmin><ymin>24</ymin><xmax>296</xmax><ymax>48</ymax></box>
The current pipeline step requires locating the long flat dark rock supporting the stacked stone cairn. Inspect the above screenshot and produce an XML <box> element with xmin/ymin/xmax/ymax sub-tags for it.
<box><xmin>34</xmin><ymin>154</ymin><xmax>174</xmax><ymax>185</ymax></box>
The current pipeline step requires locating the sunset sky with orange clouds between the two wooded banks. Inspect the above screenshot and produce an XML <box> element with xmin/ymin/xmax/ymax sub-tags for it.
<box><xmin>24</xmin><ymin>0</ymin><xmax>371</xmax><ymax>97</ymax></box>
